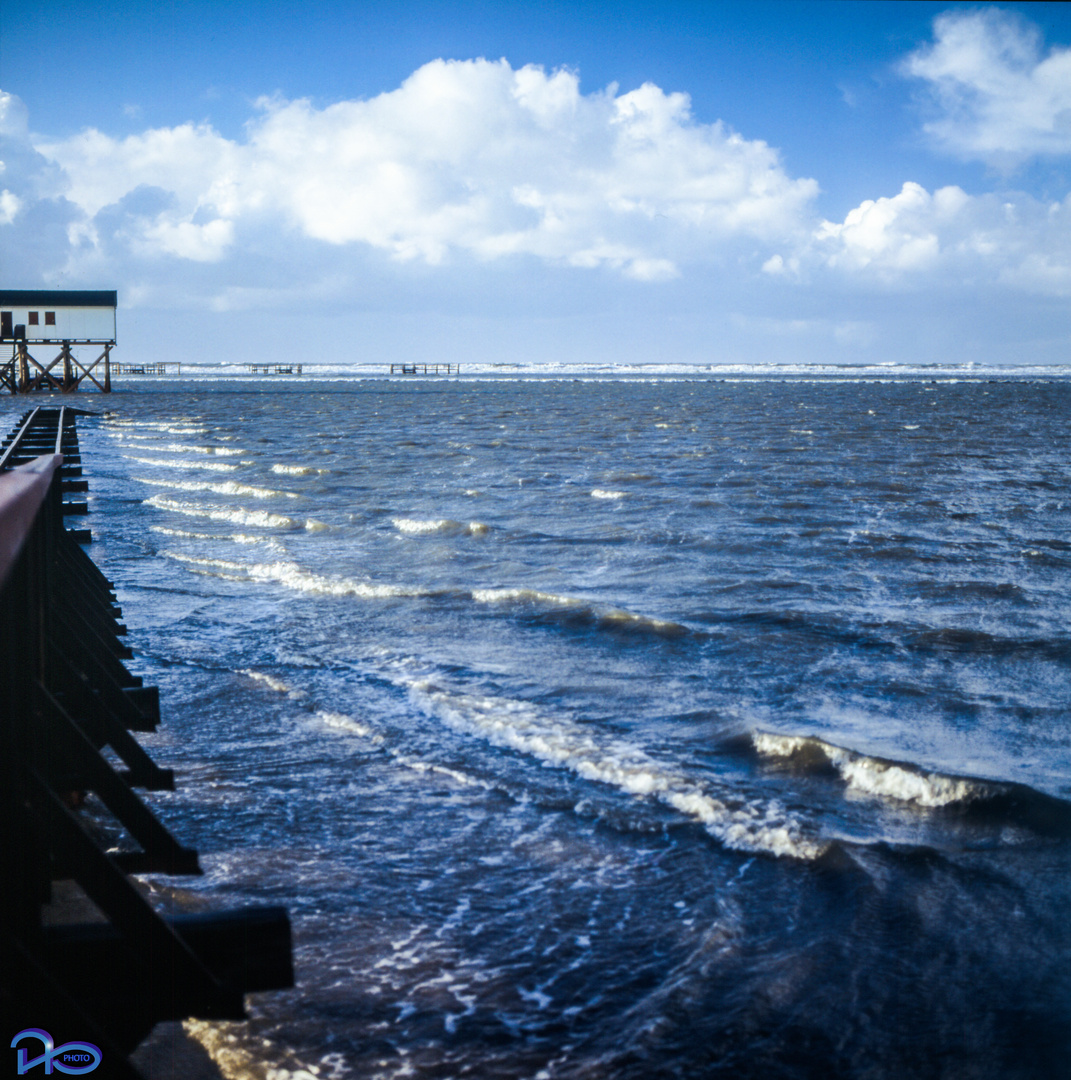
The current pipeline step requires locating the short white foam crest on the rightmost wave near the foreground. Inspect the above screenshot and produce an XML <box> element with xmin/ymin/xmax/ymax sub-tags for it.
<box><xmin>751</xmin><ymin>731</ymin><xmax>1000</xmax><ymax>807</ymax></box>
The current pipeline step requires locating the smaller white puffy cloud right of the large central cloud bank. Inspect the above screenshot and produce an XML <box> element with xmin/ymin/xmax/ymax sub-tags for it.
<box><xmin>807</xmin><ymin>181</ymin><xmax>1071</xmax><ymax>296</ymax></box>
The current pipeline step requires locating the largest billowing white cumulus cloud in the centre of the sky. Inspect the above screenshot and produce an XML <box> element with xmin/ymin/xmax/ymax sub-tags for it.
<box><xmin>37</xmin><ymin>60</ymin><xmax>817</xmax><ymax>281</ymax></box>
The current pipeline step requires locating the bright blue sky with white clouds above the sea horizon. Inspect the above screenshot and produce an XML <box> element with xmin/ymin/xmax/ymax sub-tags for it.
<box><xmin>0</xmin><ymin>0</ymin><xmax>1071</xmax><ymax>365</ymax></box>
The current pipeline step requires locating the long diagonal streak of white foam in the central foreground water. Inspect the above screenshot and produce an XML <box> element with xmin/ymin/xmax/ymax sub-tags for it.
<box><xmin>408</xmin><ymin>679</ymin><xmax>825</xmax><ymax>859</ymax></box>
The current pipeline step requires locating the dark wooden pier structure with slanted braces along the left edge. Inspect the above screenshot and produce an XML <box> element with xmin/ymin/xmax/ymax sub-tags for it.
<box><xmin>0</xmin><ymin>408</ymin><xmax>294</xmax><ymax>1080</ymax></box>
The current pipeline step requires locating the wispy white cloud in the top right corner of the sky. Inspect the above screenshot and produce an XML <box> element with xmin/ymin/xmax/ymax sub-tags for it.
<box><xmin>904</xmin><ymin>9</ymin><xmax>1071</xmax><ymax>167</ymax></box>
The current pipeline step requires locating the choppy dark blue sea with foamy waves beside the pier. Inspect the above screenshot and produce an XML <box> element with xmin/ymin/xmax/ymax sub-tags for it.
<box><xmin>16</xmin><ymin>365</ymin><xmax>1071</xmax><ymax>1080</ymax></box>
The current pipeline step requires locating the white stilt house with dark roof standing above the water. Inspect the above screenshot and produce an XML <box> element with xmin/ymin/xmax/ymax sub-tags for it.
<box><xmin>0</xmin><ymin>289</ymin><xmax>117</xmax><ymax>394</ymax></box>
